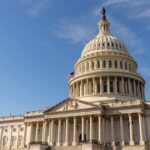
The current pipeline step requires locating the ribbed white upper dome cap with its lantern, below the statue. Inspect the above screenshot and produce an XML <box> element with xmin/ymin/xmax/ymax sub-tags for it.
<box><xmin>81</xmin><ymin>20</ymin><xmax>128</xmax><ymax>56</ymax></box>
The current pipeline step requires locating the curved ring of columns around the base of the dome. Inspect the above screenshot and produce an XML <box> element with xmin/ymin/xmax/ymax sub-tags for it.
<box><xmin>70</xmin><ymin>76</ymin><xmax>145</xmax><ymax>99</ymax></box>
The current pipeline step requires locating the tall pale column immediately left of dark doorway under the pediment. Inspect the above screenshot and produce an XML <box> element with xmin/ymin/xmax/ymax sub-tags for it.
<box><xmin>72</xmin><ymin>117</ymin><xmax>77</xmax><ymax>146</ymax></box>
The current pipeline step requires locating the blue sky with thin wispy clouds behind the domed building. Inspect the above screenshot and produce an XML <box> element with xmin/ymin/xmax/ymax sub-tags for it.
<box><xmin>0</xmin><ymin>0</ymin><xmax>150</xmax><ymax>116</ymax></box>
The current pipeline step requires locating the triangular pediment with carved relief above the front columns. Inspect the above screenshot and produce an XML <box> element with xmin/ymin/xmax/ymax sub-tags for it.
<box><xmin>43</xmin><ymin>98</ymin><xmax>98</xmax><ymax>113</ymax></box>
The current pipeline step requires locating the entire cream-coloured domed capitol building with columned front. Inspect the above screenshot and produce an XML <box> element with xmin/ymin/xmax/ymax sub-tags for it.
<box><xmin>0</xmin><ymin>9</ymin><xmax>150</xmax><ymax>150</ymax></box>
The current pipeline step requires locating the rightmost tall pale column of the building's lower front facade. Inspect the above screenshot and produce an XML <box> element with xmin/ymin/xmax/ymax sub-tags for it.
<box><xmin>138</xmin><ymin>113</ymin><xmax>144</xmax><ymax>145</ymax></box>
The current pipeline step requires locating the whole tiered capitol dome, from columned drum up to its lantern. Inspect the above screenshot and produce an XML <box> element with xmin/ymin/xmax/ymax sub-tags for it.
<box><xmin>69</xmin><ymin>7</ymin><xmax>145</xmax><ymax>102</ymax></box>
